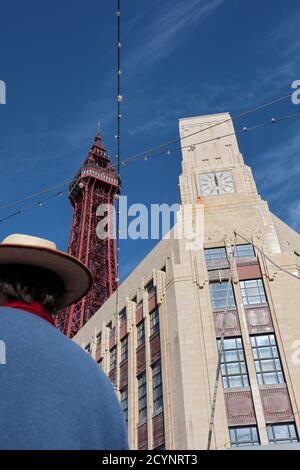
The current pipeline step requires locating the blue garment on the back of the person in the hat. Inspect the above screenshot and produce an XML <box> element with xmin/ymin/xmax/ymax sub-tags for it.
<box><xmin>0</xmin><ymin>307</ymin><xmax>128</xmax><ymax>450</ymax></box>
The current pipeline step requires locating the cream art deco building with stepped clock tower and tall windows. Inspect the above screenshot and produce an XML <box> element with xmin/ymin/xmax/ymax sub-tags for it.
<box><xmin>74</xmin><ymin>113</ymin><xmax>300</xmax><ymax>449</ymax></box>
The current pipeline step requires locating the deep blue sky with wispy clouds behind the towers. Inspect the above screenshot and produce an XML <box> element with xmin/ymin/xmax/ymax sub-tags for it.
<box><xmin>0</xmin><ymin>0</ymin><xmax>300</xmax><ymax>277</ymax></box>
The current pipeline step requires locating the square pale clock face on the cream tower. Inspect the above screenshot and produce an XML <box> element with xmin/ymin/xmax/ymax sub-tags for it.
<box><xmin>199</xmin><ymin>171</ymin><xmax>235</xmax><ymax>196</ymax></box>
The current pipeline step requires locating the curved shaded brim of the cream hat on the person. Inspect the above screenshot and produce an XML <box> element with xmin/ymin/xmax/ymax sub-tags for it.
<box><xmin>0</xmin><ymin>244</ymin><xmax>93</xmax><ymax>308</ymax></box>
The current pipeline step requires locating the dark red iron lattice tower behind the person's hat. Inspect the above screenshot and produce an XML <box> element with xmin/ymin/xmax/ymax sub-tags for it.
<box><xmin>57</xmin><ymin>133</ymin><xmax>120</xmax><ymax>337</ymax></box>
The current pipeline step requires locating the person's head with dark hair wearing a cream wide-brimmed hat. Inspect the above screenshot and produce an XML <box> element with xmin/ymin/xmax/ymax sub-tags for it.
<box><xmin>0</xmin><ymin>233</ymin><xmax>93</xmax><ymax>314</ymax></box>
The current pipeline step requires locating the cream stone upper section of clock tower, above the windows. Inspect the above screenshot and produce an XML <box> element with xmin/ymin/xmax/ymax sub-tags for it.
<box><xmin>179</xmin><ymin>113</ymin><xmax>280</xmax><ymax>252</ymax></box>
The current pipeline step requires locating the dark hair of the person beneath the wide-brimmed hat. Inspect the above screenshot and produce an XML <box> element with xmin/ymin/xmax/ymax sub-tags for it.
<box><xmin>0</xmin><ymin>264</ymin><xmax>64</xmax><ymax>314</ymax></box>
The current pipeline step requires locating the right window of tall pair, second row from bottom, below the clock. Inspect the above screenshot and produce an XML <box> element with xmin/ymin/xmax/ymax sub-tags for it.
<box><xmin>251</xmin><ymin>334</ymin><xmax>285</xmax><ymax>385</ymax></box>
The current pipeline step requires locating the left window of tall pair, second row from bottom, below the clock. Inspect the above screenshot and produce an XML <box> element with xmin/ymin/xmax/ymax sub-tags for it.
<box><xmin>218</xmin><ymin>338</ymin><xmax>249</xmax><ymax>388</ymax></box>
